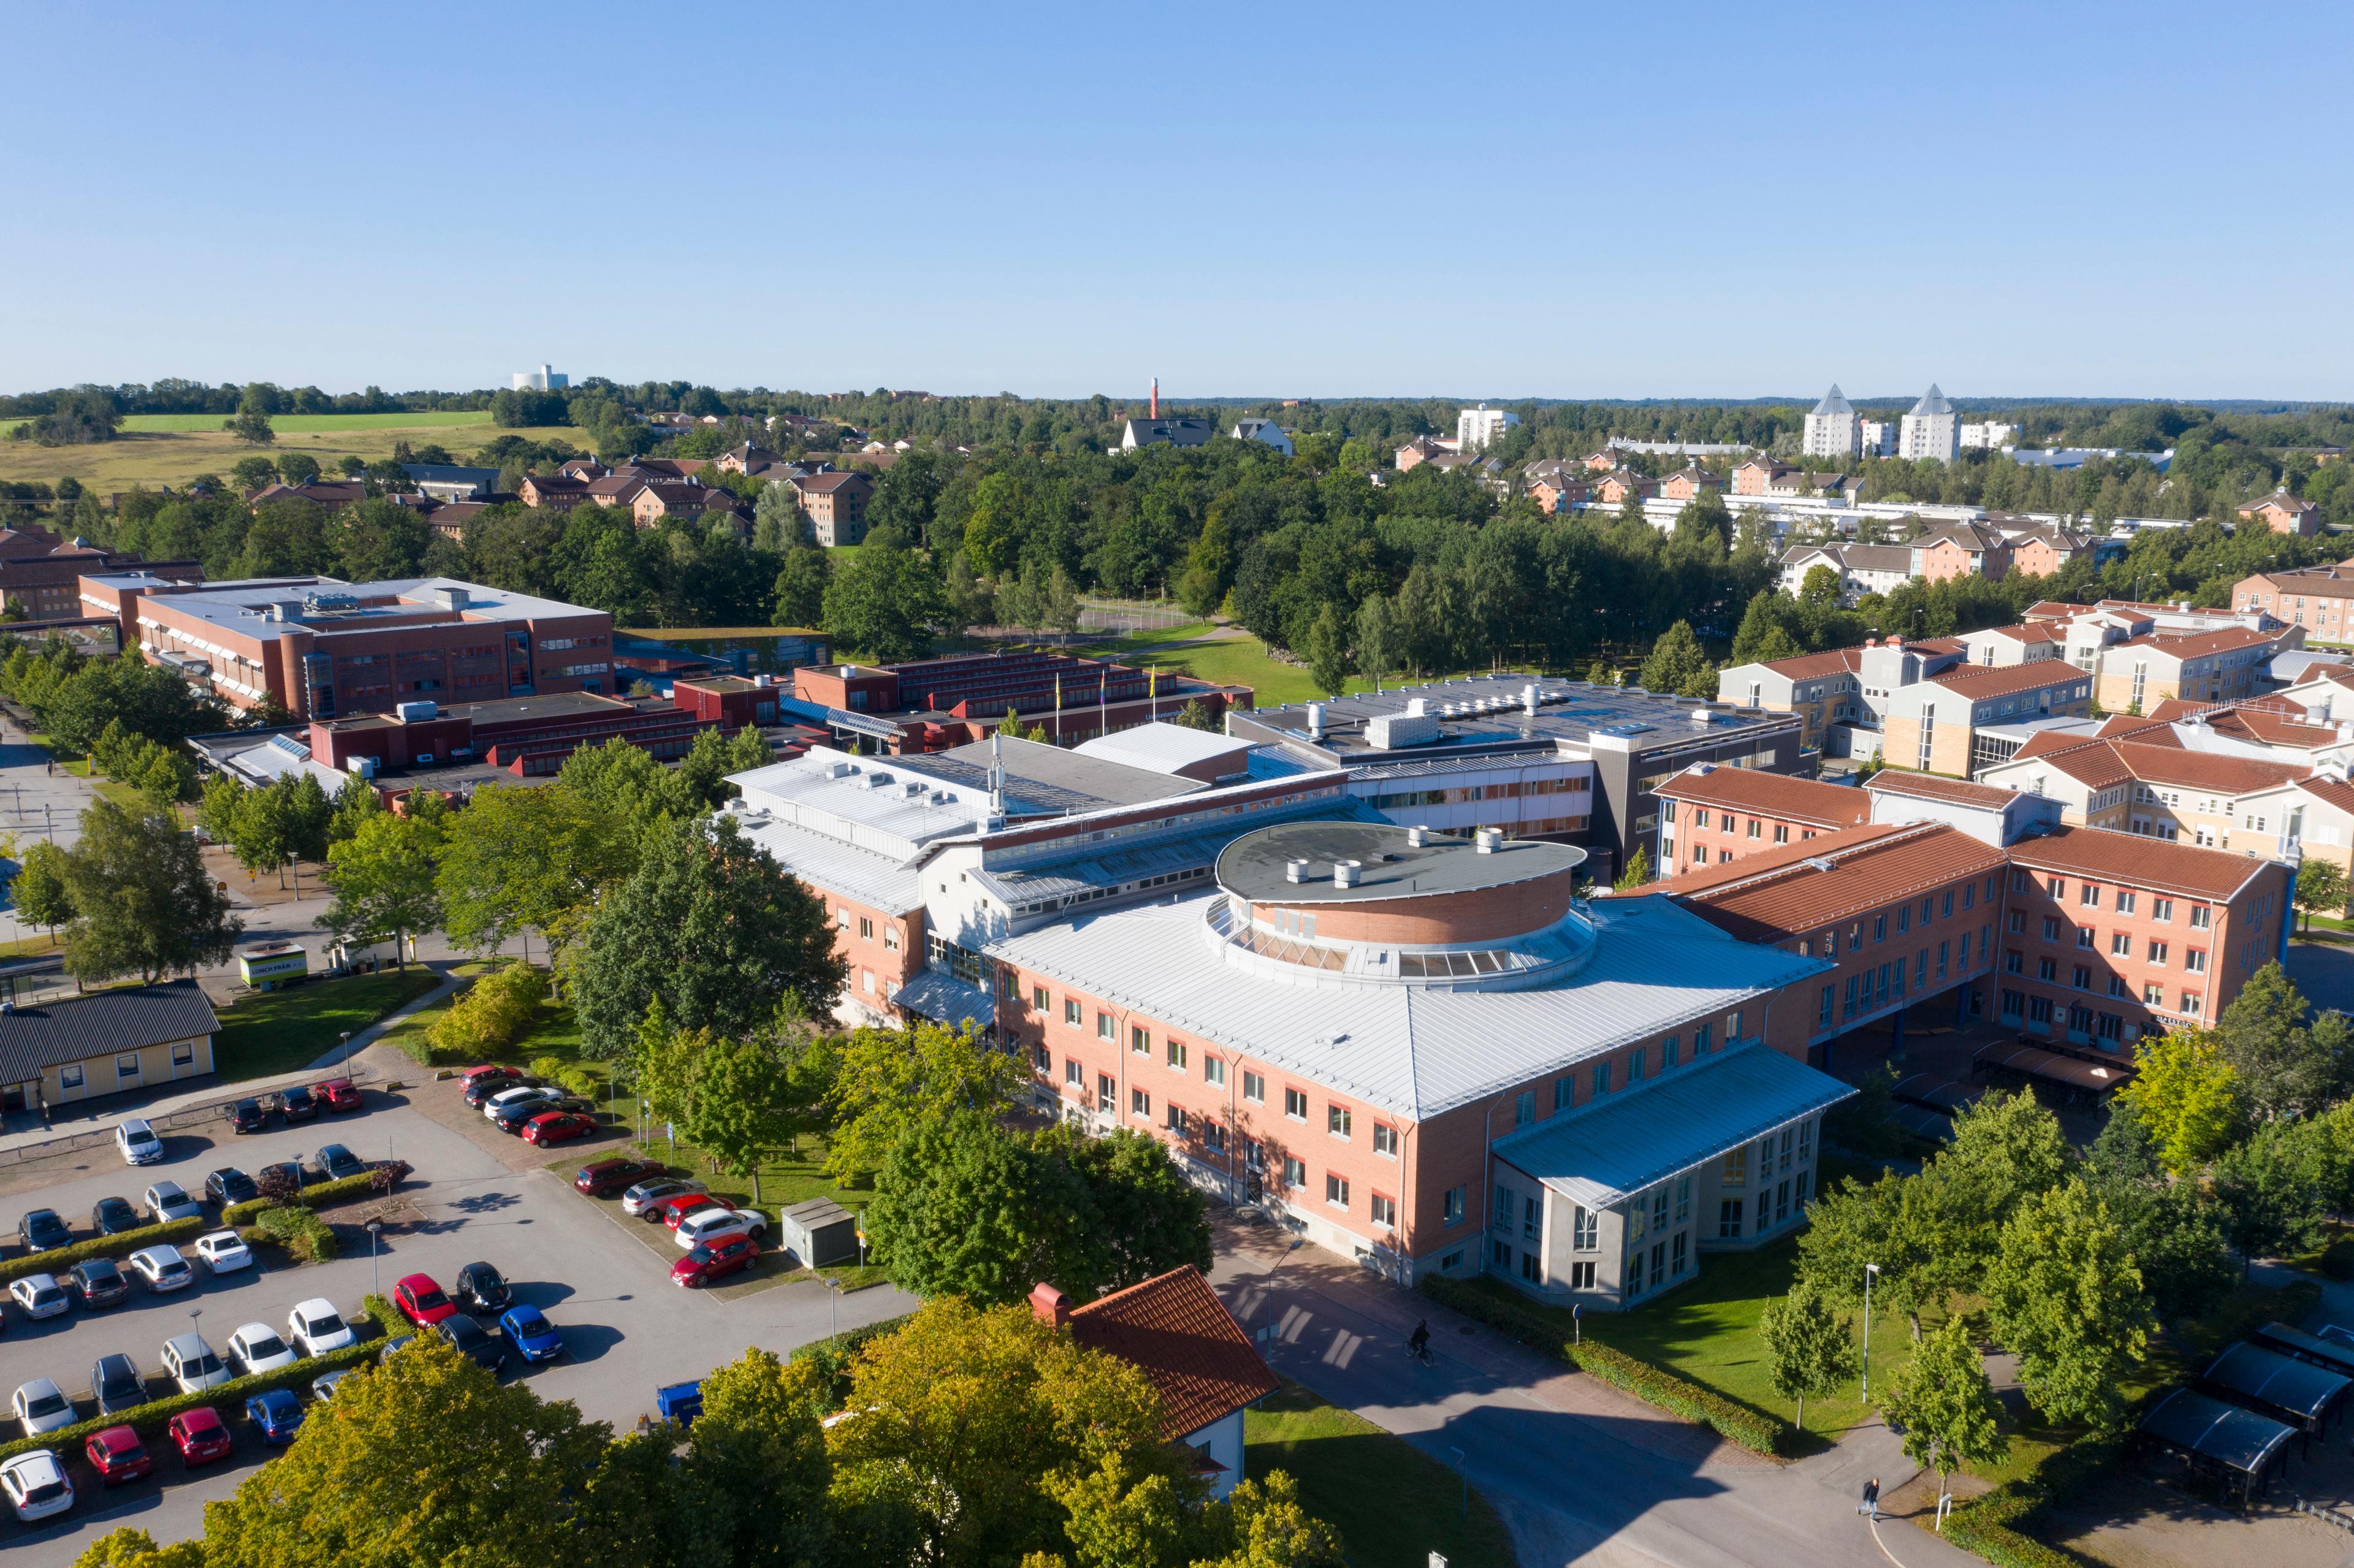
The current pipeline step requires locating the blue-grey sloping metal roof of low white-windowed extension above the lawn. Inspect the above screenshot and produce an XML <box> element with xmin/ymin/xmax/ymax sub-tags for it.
<box><xmin>1495</xmin><ymin>1043</ymin><xmax>1855</xmax><ymax>1208</ymax></box>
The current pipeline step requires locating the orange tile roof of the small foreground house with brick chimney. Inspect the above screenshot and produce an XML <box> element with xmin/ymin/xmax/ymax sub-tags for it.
<box><xmin>1068</xmin><ymin>1265</ymin><xmax>1281</xmax><ymax>1439</ymax></box>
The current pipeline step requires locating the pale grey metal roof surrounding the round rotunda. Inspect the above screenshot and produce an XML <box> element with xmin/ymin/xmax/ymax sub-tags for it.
<box><xmin>986</xmin><ymin>897</ymin><xmax>1827</xmax><ymax>1118</ymax></box>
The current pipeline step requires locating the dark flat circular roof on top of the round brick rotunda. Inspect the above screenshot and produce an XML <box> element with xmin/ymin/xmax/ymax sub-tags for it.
<box><xmin>1217</xmin><ymin>821</ymin><xmax>1586</xmax><ymax>904</ymax></box>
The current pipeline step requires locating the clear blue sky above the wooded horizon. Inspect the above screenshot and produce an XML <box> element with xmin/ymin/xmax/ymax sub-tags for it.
<box><xmin>0</xmin><ymin>0</ymin><xmax>2354</xmax><ymax>398</ymax></box>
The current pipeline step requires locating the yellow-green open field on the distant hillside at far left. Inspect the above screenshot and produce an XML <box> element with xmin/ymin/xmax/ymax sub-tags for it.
<box><xmin>0</xmin><ymin>414</ymin><xmax>586</xmax><ymax>497</ymax></box>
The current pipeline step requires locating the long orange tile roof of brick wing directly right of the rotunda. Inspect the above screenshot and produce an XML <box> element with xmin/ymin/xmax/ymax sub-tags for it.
<box><xmin>1664</xmin><ymin>821</ymin><xmax>2003</xmax><ymax>942</ymax></box>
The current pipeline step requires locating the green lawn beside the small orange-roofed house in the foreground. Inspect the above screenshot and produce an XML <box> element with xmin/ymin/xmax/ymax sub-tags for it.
<box><xmin>1243</xmin><ymin>1382</ymin><xmax>1514</xmax><ymax>1568</ymax></box>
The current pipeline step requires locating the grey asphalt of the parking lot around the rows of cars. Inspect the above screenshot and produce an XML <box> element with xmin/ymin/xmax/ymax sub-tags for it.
<box><xmin>0</xmin><ymin>1083</ymin><xmax>913</xmax><ymax>1566</ymax></box>
